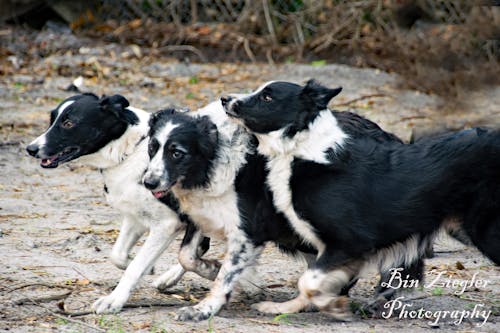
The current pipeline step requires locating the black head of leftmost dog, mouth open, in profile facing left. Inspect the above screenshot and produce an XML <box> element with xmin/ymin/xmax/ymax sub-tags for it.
<box><xmin>26</xmin><ymin>93</ymin><xmax>139</xmax><ymax>168</ymax></box>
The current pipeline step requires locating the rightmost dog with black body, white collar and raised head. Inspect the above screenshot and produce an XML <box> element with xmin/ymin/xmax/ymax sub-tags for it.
<box><xmin>222</xmin><ymin>81</ymin><xmax>500</xmax><ymax>318</ymax></box>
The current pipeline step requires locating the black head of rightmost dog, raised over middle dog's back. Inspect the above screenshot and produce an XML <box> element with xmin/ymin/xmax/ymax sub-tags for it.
<box><xmin>221</xmin><ymin>80</ymin><xmax>342</xmax><ymax>135</ymax></box>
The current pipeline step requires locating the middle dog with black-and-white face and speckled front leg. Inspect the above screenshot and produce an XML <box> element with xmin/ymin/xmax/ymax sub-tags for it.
<box><xmin>144</xmin><ymin>98</ymin><xmax>416</xmax><ymax>320</ymax></box>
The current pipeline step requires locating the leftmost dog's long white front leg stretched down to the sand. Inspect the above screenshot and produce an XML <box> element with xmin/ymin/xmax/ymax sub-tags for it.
<box><xmin>92</xmin><ymin>216</ymin><xmax>182</xmax><ymax>313</ymax></box>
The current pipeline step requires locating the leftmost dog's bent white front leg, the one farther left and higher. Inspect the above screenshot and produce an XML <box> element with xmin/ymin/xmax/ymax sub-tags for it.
<box><xmin>110</xmin><ymin>216</ymin><xmax>146</xmax><ymax>269</ymax></box>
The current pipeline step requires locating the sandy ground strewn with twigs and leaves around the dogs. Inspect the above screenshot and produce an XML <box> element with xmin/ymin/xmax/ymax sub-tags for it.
<box><xmin>0</xmin><ymin>50</ymin><xmax>500</xmax><ymax>333</ymax></box>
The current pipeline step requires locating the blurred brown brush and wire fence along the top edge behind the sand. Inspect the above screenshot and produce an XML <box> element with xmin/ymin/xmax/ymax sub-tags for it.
<box><xmin>0</xmin><ymin>0</ymin><xmax>500</xmax><ymax>97</ymax></box>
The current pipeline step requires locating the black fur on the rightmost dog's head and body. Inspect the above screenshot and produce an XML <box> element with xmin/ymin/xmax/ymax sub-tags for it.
<box><xmin>228</xmin><ymin>78</ymin><xmax>500</xmax><ymax>269</ymax></box>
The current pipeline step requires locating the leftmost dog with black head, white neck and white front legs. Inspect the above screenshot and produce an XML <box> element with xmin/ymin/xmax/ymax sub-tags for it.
<box><xmin>27</xmin><ymin>94</ymin><xmax>222</xmax><ymax>313</ymax></box>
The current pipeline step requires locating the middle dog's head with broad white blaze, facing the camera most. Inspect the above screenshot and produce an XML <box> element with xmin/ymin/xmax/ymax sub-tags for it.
<box><xmin>143</xmin><ymin>110</ymin><xmax>218</xmax><ymax>198</ymax></box>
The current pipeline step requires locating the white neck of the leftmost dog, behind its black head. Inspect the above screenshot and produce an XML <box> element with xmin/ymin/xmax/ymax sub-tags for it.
<box><xmin>79</xmin><ymin>107</ymin><xmax>150</xmax><ymax>170</ymax></box>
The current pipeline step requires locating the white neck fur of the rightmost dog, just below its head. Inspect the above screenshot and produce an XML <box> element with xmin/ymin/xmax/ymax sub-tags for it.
<box><xmin>255</xmin><ymin>109</ymin><xmax>348</xmax><ymax>164</ymax></box>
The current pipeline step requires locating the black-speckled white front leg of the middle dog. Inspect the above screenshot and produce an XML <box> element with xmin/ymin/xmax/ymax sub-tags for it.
<box><xmin>177</xmin><ymin>229</ymin><xmax>262</xmax><ymax>321</ymax></box>
